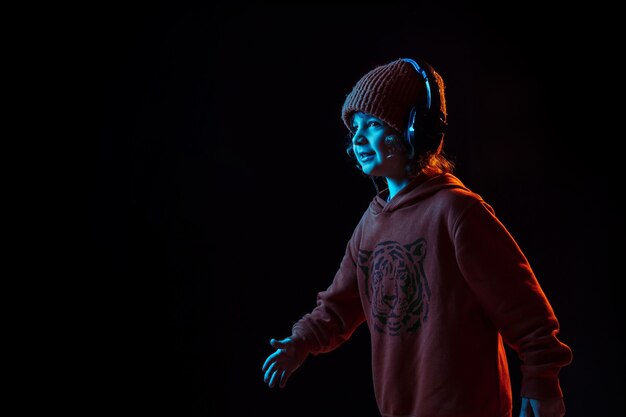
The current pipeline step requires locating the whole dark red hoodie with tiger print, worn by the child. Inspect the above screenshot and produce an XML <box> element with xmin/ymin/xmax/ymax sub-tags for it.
<box><xmin>293</xmin><ymin>174</ymin><xmax>572</xmax><ymax>417</ymax></box>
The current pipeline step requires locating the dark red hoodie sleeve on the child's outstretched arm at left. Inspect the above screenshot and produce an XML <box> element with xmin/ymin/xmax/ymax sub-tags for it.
<box><xmin>292</xmin><ymin>232</ymin><xmax>365</xmax><ymax>355</ymax></box>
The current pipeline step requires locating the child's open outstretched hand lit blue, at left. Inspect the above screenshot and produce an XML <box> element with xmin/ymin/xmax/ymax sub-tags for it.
<box><xmin>262</xmin><ymin>337</ymin><xmax>309</xmax><ymax>388</ymax></box>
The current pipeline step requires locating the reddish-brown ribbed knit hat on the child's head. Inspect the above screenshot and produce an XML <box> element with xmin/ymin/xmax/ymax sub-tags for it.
<box><xmin>341</xmin><ymin>59</ymin><xmax>426</xmax><ymax>134</ymax></box>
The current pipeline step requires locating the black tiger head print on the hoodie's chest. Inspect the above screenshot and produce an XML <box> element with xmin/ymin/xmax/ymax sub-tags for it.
<box><xmin>358</xmin><ymin>238</ymin><xmax>430</xmax><ymax>336</ymax></box>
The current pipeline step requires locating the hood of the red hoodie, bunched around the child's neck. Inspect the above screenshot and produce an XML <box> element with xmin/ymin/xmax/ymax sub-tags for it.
<box><xmin>369</xmin><ymin>174</ymin><xmax>470</xmax><ymax>215</ymax></box>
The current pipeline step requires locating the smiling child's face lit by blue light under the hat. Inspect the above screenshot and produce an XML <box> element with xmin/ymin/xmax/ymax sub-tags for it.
<box><xmin>351</xmin><ymin>112</ymin><xmax>408</xmax><ymax>179</ymax></box>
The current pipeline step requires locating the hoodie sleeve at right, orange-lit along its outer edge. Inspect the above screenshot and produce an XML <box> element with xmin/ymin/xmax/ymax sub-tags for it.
<box><xmin>454</xmin><ymin>200</ymin><xmax>572</xmax><ymax>399</ymax></box>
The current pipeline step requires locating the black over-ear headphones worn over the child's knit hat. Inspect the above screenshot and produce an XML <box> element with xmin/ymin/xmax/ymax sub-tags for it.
<box><xmin>402</xmin><ymin>58</ymin><xmax>448</xmax><ymax>158</ymax></box>
